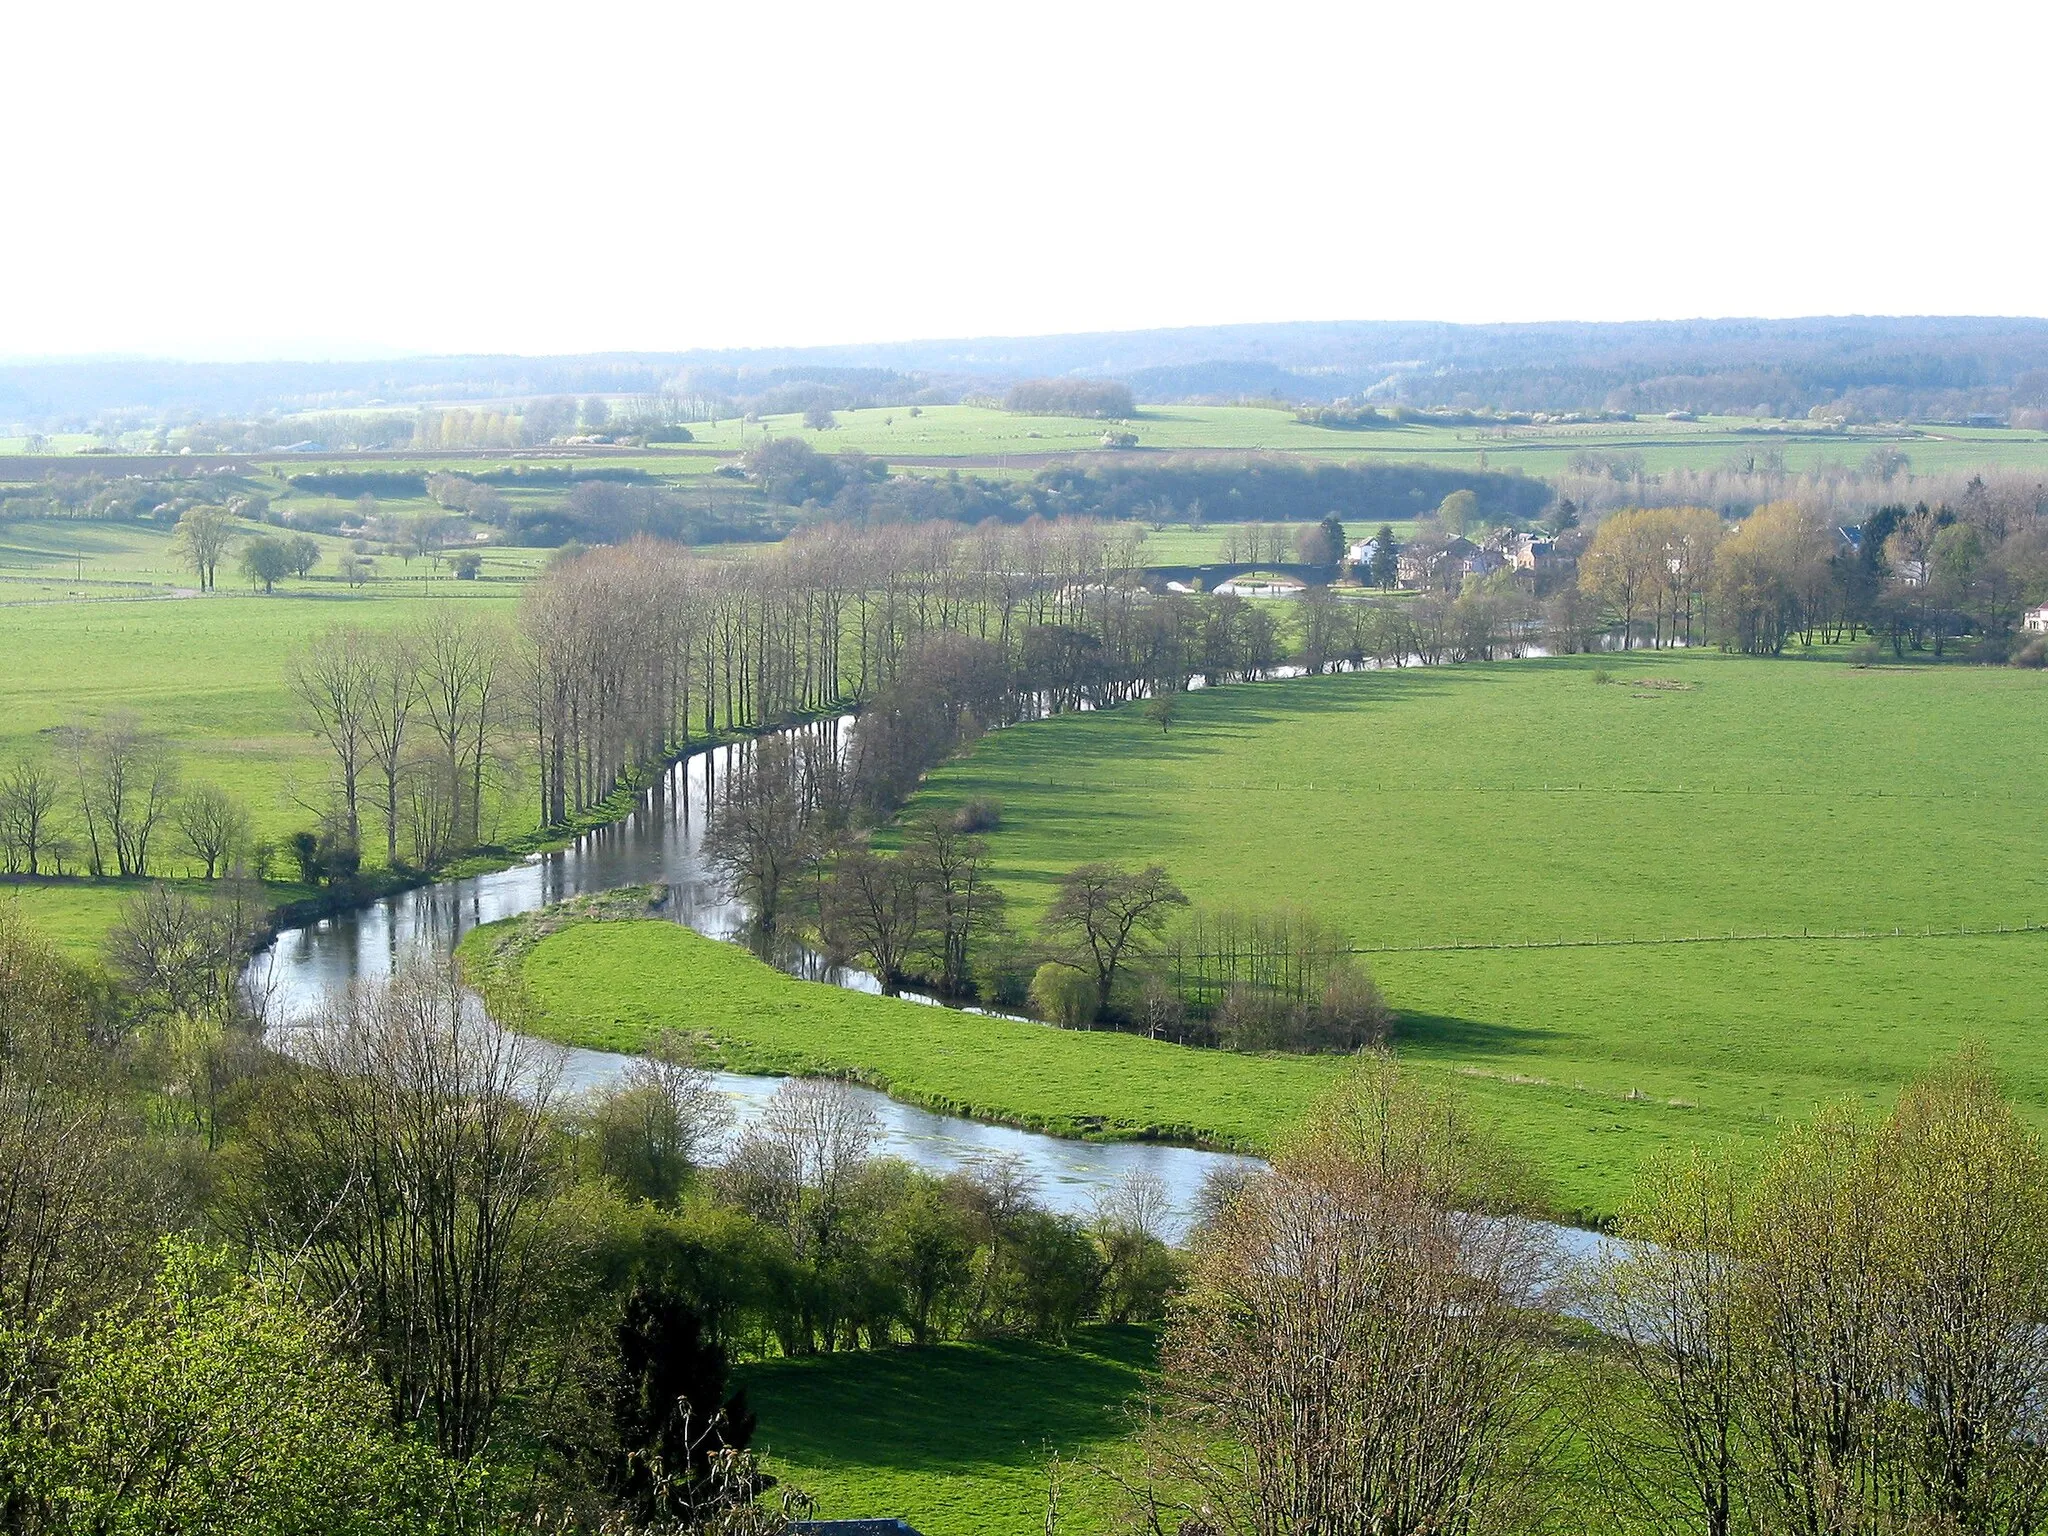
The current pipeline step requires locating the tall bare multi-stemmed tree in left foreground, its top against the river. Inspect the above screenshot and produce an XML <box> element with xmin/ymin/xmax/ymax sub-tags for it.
<box><xmin>229</xmin><ymin>969</ymin><xmax>561</xmax><ymax>1458</ymax></box>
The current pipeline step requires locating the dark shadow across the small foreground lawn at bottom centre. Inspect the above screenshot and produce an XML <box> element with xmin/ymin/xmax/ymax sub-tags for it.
<box><xmin>737</xmin><ymin>1325</ymin><xmax>1157</xmax><ymax>1473</ymax></box>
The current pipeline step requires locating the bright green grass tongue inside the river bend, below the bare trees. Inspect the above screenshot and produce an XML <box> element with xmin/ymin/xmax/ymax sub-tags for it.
<box><xmin>459</xmin><ymin>918</ymin><xmax>1341</xmax><ymax>1147</ymax></box>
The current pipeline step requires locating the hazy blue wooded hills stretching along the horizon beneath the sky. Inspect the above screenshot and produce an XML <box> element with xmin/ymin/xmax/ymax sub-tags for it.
<box><xmin>12</xmin><ymin>315</ymin><xmax>2048</xmax><ymax>426</ymax></box>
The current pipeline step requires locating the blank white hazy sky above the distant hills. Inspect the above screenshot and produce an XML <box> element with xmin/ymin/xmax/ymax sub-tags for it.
<box><xmin>0</xmin><ymin>0</ymin><xmax>2048</xmax><ymax>356</ymax></box>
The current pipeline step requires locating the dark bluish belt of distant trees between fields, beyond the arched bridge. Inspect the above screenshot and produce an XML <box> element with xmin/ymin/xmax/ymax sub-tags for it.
<box><xmin>745</xmin><ymin>438</ymin><xmax>1550</xmax><ymax>524</ymax></box>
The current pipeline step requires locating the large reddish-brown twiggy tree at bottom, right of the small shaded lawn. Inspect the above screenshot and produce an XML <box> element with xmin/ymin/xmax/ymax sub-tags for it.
<box><xmin>1141</xmin><ymin>1061</ymin><xmax>1544</xmax><ymax>1536</ymax></box>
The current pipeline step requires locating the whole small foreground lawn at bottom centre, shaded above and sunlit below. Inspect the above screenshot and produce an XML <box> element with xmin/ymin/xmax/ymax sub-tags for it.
<box><xmin>739</xmin><ymin>1327</ymin><xmax>1155</xmax><ymax>1536</ymax></box>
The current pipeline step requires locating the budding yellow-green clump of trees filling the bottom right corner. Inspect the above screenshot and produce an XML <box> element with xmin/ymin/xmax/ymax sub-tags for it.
<box><xmin>1587</xmin><ymin>1057</ymin><xmax>2048</xmax><ymax>1536</ymax></box>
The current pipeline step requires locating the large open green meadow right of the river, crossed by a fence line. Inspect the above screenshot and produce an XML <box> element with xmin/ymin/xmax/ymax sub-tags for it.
<box><xmin>884</xmin><ymin>655</ymin><xmax>2048</xmax><ymax>1214</ymax></box>
